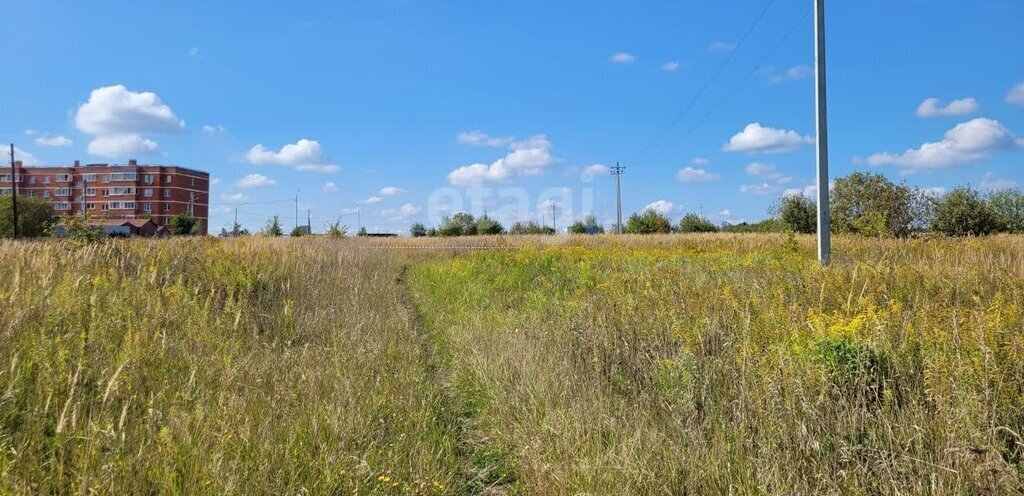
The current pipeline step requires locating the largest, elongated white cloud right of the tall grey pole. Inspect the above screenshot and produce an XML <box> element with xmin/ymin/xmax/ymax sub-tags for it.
<box><xmin>867</xmin><ymin>118</ymin><xmax>1024</xmax><ymax>173</ymax></box>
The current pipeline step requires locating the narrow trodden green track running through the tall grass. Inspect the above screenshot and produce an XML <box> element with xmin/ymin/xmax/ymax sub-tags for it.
<box><xmin>396</xmin><ymin>264</ymin><xmax>522</xmax><ymax>495</ymax></box>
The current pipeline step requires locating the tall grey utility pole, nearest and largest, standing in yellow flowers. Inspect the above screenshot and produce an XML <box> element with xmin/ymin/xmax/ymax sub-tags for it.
<box><xmin>814</xmin><ymin>0</ymin><xmax>831</xmax><ymax>265</ymax></box>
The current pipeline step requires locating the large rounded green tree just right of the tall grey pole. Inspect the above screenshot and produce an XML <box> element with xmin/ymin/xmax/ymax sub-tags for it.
<box><xmin>830</xmin><ymin>172</ymin><xmax>913</xmax><ymax>236</ymax></box>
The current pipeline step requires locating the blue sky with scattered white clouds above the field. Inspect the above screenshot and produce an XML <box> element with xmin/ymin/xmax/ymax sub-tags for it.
<box><xmin>0</xmin><ymin>0</ymin><xmax>1024</xmax><ymax>232</ymax></box>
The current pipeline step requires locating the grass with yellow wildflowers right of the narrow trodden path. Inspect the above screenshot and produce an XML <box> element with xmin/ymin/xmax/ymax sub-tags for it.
<box><xmin>414</xmin><ymin>236</ymin><xmax>1024</xmax><ymax>494</ymax></box>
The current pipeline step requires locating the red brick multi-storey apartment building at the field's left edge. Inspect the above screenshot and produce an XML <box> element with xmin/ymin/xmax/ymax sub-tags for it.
<box><xmin>0</xmin><ymin>160</ymin><xmax>210</xmax><ymax>234</ymax></box>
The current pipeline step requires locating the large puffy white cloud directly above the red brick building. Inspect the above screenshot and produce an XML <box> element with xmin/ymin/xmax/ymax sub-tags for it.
<box><xmin>75</xmin><ymin>84</ymin><xmax>185</xmax><ymax>157</ymax></box>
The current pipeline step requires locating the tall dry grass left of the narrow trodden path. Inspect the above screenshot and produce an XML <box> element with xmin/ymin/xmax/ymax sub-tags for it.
<box><xmin>0</xmin><ymin>240</ymin><xmax>460</xmax><ymax>494</ymax></box>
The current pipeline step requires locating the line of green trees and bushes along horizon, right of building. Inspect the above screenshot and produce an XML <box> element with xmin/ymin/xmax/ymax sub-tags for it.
<box><xmin>410</xmin><ymin>172</ymin><xmax>1024</xmax><ymax>238</ymax></box>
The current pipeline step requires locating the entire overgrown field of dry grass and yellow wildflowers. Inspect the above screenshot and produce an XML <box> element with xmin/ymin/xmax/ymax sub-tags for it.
<box><xmin>0</xmin><ymin>235</ymin><xmax>1024</xmax><ymax>495</ymax></box>
